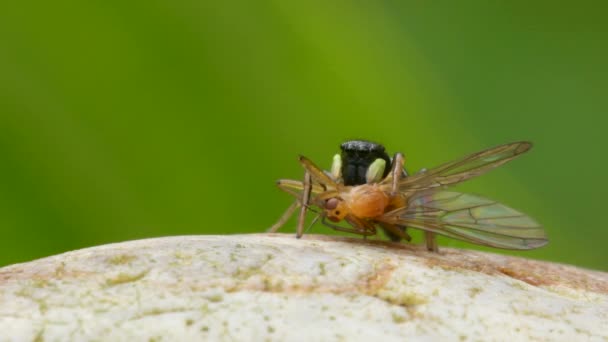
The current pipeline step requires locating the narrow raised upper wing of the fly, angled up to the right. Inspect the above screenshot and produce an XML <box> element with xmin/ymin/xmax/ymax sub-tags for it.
<box><xmin>399</xmin><ymin>141</ymin><xmax>532</xmax><ymax>193</ymax></box>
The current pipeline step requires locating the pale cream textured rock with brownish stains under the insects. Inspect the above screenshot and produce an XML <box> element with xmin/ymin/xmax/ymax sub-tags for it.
<box><xmin>0</xmin><ymin>234</ymin><xmax>608</xmax><ymax>341</ymax></box>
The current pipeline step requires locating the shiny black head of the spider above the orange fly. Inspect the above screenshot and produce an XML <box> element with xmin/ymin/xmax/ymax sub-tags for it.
<box><xmin>340</xmin><ymin>140</ymin><xmax>391</xmax><ymax>185</ymax></box>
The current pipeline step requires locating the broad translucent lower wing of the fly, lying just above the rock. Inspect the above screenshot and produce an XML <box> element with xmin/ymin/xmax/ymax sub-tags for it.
<box><xmin>381</xmin><ymin>191</ymin><xmax>548</xmax><ymax>249</ymax></box>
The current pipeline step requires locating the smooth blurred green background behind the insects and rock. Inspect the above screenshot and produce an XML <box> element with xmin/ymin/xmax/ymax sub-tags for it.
<box><xmin>0</xmin><ymin>0</ymin><xmax>608</xmax><ymax>270</ymax></box>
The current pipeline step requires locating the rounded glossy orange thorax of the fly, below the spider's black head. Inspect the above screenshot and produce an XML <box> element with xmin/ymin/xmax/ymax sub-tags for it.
<box><xmin>344</xmin><ymin>184</ymin><xmax>390</xmax><ymax>218</ymax></box>
